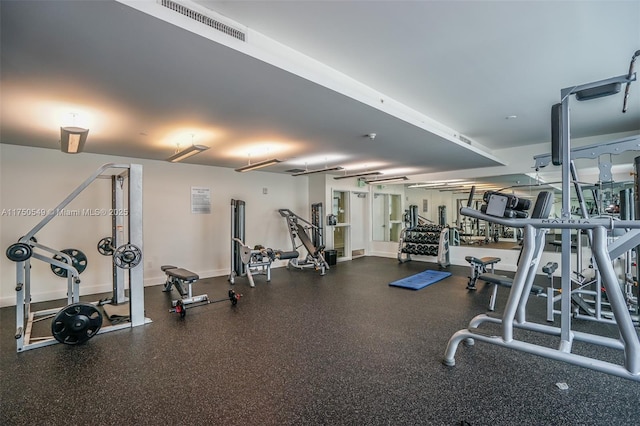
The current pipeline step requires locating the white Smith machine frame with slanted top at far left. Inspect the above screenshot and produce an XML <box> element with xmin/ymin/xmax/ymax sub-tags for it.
<box><xmin>15</xmin><ymin>163</ymin><xmax>151</xmax><ymax>352</ymax></box>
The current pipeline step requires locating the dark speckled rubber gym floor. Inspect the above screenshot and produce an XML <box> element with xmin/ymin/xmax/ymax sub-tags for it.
<box><xmin>0</xmin><ymin>257</ymin><xmax>640</xmax><ymax>426</ymax></box>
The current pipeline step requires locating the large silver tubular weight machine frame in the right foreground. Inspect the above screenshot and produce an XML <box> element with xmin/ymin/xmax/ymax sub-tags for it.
<box><xmin>443</xmin><ymin>55</ymin><xmax>640</xmax><ymax>381</ymax></box>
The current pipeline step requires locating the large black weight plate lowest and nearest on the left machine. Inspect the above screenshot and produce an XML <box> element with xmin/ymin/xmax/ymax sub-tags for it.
<box><xmin>51</xmin><ymin>303</ymin><xmax>102</xmax><ymax>345</ymax></box>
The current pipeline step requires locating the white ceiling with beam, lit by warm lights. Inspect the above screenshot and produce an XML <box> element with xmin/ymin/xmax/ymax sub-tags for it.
<box><xmin>0</xmin><ymin>0</ymin><xmax>640</xmax><ymax>186</ymax></box>
